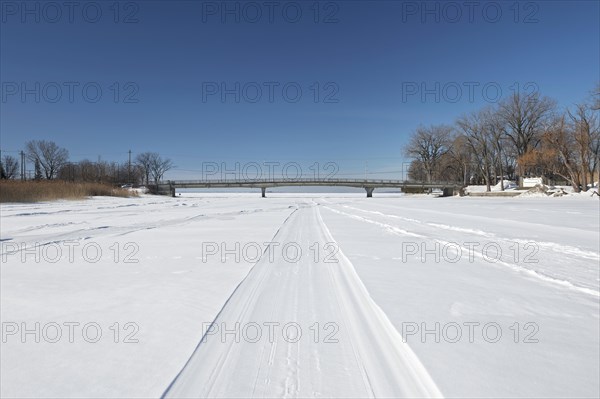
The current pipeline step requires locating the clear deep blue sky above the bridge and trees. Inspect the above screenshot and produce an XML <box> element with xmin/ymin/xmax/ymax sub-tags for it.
<box><xmin>0</xmin><ymin>0</ymin><xmax>600</xmax><ymax>178</ymax></box>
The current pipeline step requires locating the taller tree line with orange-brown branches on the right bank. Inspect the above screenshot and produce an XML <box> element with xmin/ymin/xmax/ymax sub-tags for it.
<box><xmin>404</xmin><ymin>85</ymin><xmax>600</xmax><ymax>192</ymax></box>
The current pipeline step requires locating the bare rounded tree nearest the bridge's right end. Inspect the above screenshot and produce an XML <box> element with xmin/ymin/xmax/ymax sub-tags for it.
<box><xmin>405</xmin><ymin>125</ymin><xmax>453</xmax><ymax>182</ymax></box>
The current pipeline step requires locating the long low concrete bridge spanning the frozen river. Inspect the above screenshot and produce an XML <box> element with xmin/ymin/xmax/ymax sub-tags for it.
<box><xmin>155</xmin><ymin>178</ymin><xmax>460</xmax><ymax>198</ymax></box>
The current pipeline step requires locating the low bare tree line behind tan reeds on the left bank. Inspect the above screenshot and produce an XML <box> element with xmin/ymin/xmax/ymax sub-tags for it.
<box><xmin>0</xmin><ymin>140</ymin><xmax>174</xmax><ymax>185</ymax></box>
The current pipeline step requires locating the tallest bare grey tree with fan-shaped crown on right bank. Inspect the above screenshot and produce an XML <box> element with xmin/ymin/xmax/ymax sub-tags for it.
<box><xmin>498</xmin><ymin>92</ymin><xmax>556</xmax><ymax>175</ymax></box>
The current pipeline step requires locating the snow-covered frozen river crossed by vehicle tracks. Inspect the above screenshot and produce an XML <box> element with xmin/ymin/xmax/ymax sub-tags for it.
<box><xmin>0</xmin><ymin>193</ymin><xmax>600</xmax><ymax>397</ymax></box>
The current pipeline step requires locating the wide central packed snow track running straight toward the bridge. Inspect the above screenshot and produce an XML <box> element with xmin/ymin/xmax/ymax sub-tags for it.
<box><xmin>164</xmin><ymin>203</ymin><xmax>441</xmax><ymax>398</ymax></box>
